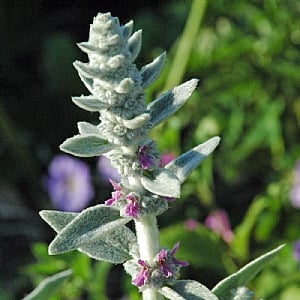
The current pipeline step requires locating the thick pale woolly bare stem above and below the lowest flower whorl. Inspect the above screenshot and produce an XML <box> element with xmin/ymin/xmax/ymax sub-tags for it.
<box><xmin>135</xmin><ymin>215</ymin><xmax>162</xmax><ymax>300</ymax></box>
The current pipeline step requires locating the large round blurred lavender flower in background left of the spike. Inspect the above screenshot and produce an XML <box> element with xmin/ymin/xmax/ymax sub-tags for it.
<box><xmin>45</xmin><ymin>154</ymin><xmax>94</xmax><ymax>212</ymax></box>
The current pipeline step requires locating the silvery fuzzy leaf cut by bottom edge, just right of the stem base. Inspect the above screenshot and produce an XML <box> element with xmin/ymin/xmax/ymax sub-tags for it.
<box><xmin>159</xmin><ymin>280</ymin><xmax>218</xmax><ymax>300</ymax></box>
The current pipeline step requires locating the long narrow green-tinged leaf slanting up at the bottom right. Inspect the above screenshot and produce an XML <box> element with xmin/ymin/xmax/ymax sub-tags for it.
<box><xmin>212</xmin><ymin>245</ymin><xmax>284</xmax><ymax>297</ymax></box>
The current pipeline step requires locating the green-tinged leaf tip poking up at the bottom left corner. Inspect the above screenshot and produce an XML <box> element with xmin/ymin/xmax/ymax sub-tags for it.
<box><xmin>23</xmin><ymin>270</ymin><xmax>72</xmax><ymax>300</ymax></box>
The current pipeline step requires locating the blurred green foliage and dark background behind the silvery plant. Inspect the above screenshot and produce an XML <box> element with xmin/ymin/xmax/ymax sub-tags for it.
<box><xmin>0</xmin><ymin>0</ymin><xmax>300</xmax><ymax>300</ymax></box>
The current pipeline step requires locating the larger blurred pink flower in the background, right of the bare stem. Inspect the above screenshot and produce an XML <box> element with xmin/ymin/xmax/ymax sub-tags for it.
<box><xmin>204</xmin><ymin>209</ymin><xmax>234</xmax><ymax>243</ymax></box>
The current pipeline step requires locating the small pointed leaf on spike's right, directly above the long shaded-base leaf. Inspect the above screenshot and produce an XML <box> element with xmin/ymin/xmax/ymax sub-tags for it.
<box><xmin>140</xmin><ymin>52</ymin><xmax>166</xmax><ymax>89</ymax></box>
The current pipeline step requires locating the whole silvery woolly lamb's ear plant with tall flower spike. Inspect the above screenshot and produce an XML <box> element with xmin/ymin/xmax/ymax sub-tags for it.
<box><xmin>25</xmin><ymin>13</ymin><xmax>281</xmax><ymax>300</ymax></box>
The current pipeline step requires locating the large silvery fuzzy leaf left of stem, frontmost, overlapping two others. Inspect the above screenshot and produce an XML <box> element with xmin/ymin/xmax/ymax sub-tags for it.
<box><xmin>49</xmin><ymin>204</ymin><xmax>129</xmax><ymax>254</ymax></box>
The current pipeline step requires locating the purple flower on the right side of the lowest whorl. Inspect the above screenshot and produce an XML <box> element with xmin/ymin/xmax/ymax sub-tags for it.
<box><xmin>156</xmin><ymin>242</ymin><xmax>189</xmax><ymax>278</ymax></box>
